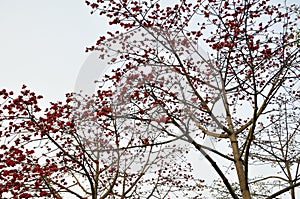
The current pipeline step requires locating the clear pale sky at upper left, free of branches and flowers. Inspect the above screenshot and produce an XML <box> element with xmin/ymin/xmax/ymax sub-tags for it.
<box><xmin>0</xmin><ymin>0</ymin><xmax>107</xmax><ymax>104</ymax></box>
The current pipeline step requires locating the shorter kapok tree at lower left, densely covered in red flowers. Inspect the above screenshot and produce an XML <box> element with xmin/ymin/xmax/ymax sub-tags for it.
<box><xmin>0</xmin><ymin>90</ymin><xmax>202</xmax><ymax>199</ymax></box>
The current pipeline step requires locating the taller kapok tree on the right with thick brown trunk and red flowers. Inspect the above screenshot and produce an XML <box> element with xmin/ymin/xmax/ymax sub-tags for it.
<box><xmin>81</xmin><ymin>0</ymin><xmax>299</xmax><ymax>198</ymax></box>
